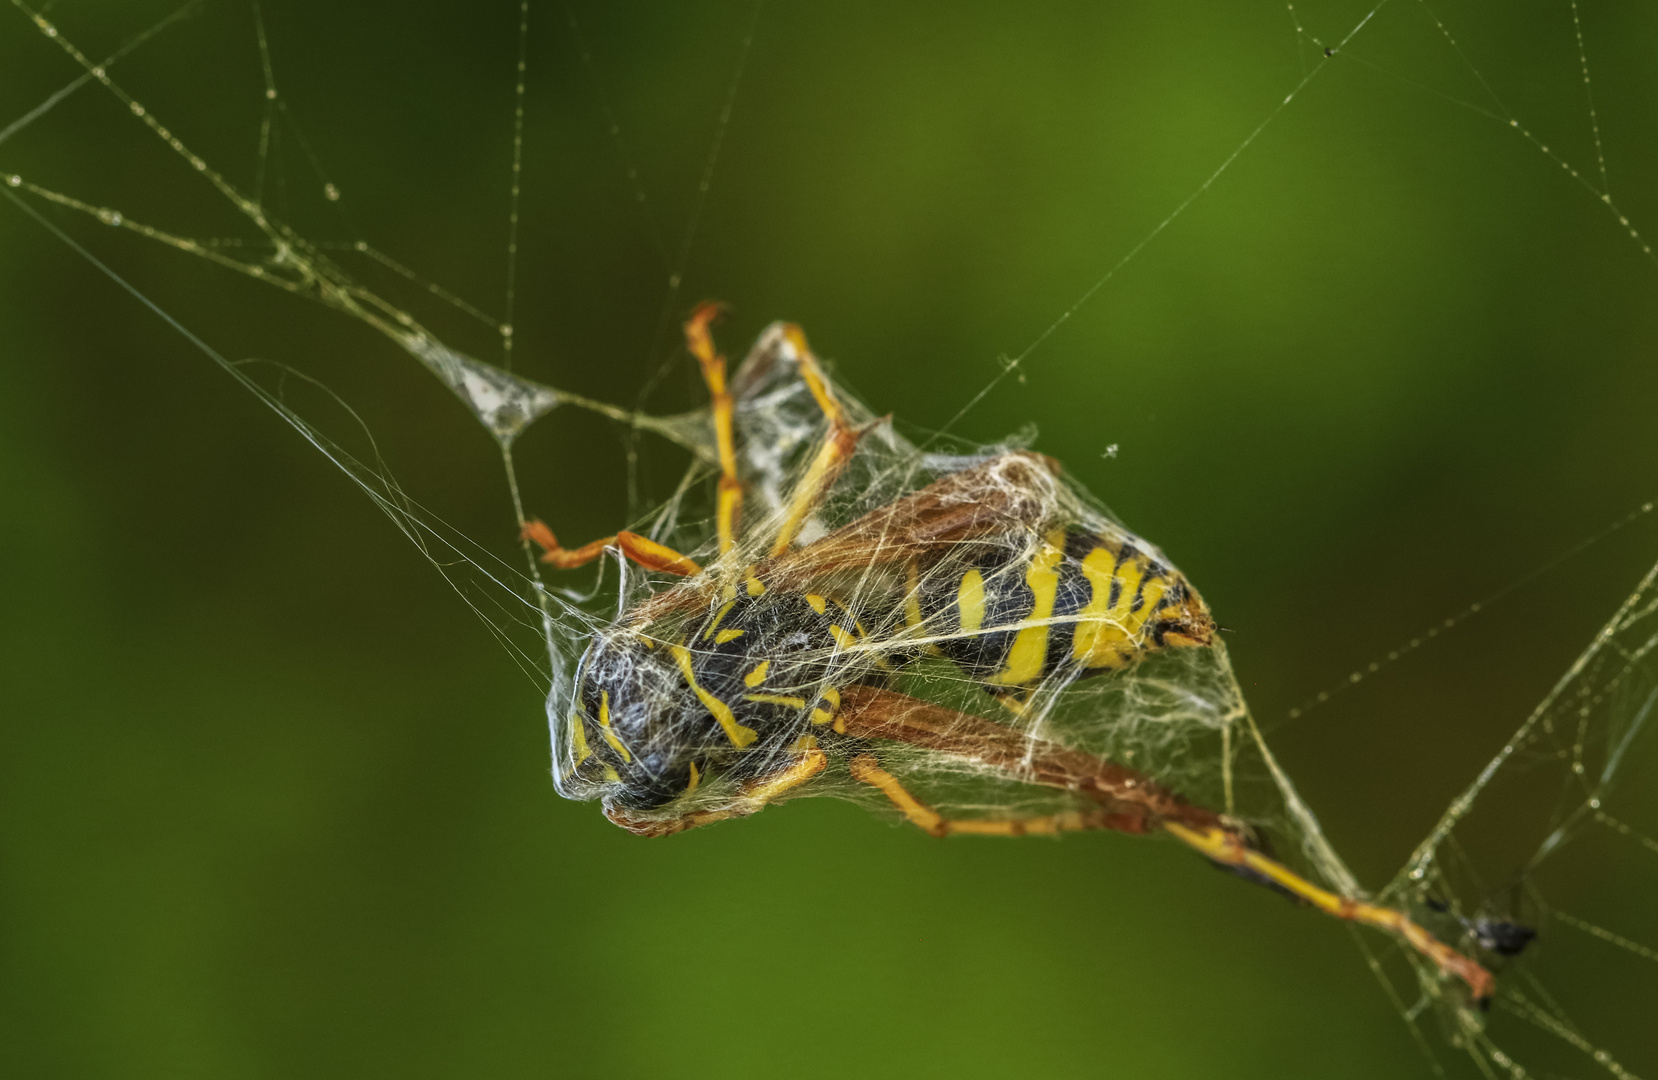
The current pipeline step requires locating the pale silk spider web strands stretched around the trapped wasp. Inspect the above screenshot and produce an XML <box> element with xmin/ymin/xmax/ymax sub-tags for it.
<box><xmin>0</xmin><ymin>0</ymin><xmax>1658</xmax><ymax>1077</ymax></box>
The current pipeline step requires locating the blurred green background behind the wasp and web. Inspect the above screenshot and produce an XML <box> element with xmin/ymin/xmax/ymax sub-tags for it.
<box><xmin>0</xmin><ymin>0</ymin><xmax>1658</xmax><ymax>1077</ymax></box>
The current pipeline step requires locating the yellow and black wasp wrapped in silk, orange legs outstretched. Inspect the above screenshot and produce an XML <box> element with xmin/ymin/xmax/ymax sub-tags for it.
<box><xmin>522</xmin><ymin>304</ymin><xmax>1494</xmax><ymax>1004</ymax></box>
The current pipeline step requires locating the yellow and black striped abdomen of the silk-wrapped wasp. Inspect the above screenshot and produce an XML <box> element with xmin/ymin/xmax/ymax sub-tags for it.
<box><xmin>909</xmin><ymin>529</ymin><xmax>1214</xmax><ymax>692</ymax></box>
